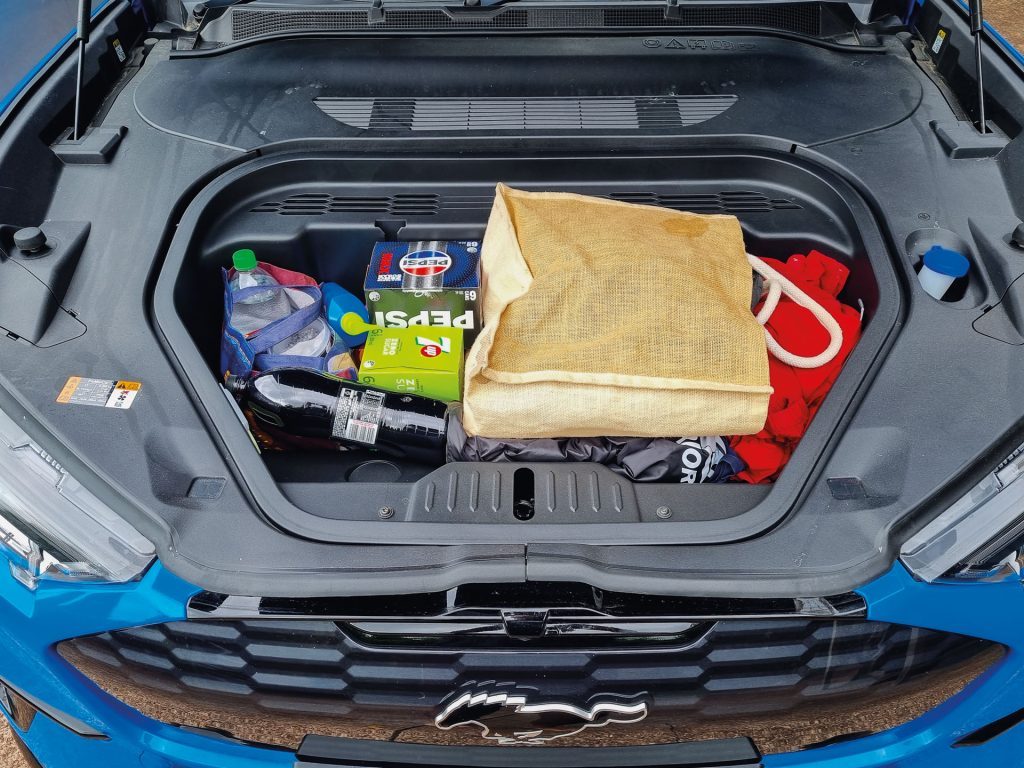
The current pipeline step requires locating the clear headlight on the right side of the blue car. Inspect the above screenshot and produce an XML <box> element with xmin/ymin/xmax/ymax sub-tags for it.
<box><xmin>900</xmin><ymin>444</ymin><xmax>1024</xmax><ymax>582</ymax></box>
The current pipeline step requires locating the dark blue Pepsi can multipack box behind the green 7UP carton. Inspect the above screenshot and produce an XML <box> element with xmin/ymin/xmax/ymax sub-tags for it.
<box><xmin>364</xmin><ymin>240</ymin><xmax>481</xmax><ymax>349</ymax></box>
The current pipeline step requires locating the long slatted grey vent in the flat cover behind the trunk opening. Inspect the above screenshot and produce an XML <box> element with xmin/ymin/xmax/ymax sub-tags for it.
<box><xmin>313</xmin><ymin>95</ymin><xmax>736</xmax><ymax>133</ymax></box>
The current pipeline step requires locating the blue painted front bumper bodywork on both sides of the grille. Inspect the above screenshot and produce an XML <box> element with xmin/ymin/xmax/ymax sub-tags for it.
<box><xmin>0</xmin><ymin>563</ymin><xmax>1024</xmax><ymax>768</ymax></box>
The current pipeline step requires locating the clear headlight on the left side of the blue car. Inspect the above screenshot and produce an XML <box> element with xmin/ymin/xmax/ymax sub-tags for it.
<box><xmin>0</xmin><ymin>405</ymin><xmax>154</xmax><ymax>589</ymax></box>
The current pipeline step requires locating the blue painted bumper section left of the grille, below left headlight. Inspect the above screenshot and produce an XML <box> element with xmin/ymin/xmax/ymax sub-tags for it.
<box><xmin>0</xmin><ymin>563</ymin><xmax>294</xmax><ymax>768</ymax></box>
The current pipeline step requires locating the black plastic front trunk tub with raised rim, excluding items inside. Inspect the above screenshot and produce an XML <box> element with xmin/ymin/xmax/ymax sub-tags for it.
<box><xmin>156</xmin><ymin>151</ymin><xmax>899</xmax><ymax>544</ymax></box>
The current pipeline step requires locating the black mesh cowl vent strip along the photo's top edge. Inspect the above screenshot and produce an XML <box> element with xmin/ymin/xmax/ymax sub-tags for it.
<box><xmin>230</xmin><ymin>3</ymin><xmax>821</xmax><ymax>40</ymax></box>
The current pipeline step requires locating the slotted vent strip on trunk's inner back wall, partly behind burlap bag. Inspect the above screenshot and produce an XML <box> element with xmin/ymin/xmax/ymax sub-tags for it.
<box><xmin>251</xmin><ymin>189</ymin><xmax>800</xmax><ymax>216</ymax></box>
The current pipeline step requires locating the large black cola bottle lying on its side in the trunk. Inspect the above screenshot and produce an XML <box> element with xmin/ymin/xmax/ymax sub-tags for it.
<box><xmin>224</xmin><ymin>369</ymin><xmax>449</xmax><ymax>465</ymax></box>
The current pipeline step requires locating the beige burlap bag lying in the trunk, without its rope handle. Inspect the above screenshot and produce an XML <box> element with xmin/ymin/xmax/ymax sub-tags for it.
<box><xmin>464</xmin><ymin>184</ymin><xmax>771</xmax><ymax>437</ymax></box>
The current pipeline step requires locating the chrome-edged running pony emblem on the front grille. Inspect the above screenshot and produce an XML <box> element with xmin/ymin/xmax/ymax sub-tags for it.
<box><xmin>434</xmin><ymin>689</ymin><xmax>647</xmax><ymax>744</ymax></box>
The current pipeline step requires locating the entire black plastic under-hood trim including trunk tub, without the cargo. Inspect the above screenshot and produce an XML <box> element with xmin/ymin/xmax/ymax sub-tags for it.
<box><xmin>0</xmin><ymin>0</ymin><xmax>1024</xmax><ymax>600</ymax></box>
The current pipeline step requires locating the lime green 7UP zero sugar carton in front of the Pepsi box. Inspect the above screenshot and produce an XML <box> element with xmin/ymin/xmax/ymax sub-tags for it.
<box><xmin>342</xmin><ymin>314</ymin><xmax>465</xmax><ymax>402</ymax></box>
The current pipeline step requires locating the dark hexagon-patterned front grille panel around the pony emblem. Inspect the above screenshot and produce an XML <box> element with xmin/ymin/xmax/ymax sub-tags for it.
<box><xmin>59</xmin><ymin>618</ymin><xmax>1000</xmax><ymax>752</ymax></box>
